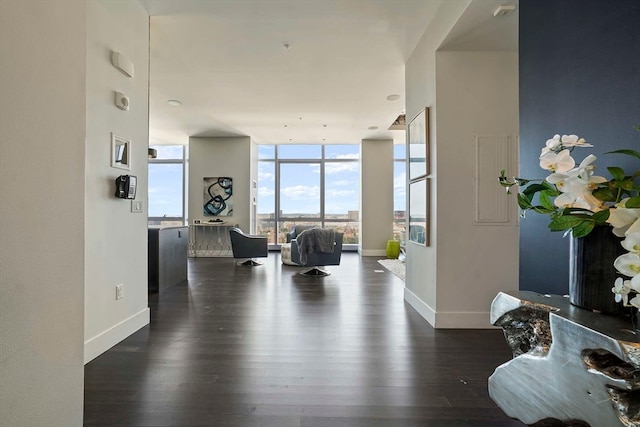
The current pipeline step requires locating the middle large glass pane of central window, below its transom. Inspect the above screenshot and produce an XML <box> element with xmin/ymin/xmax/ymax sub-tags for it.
<box><xmin>280</xmin><ymin>163</ymin><xmax>320</xmax><ymax>218</ymax></box>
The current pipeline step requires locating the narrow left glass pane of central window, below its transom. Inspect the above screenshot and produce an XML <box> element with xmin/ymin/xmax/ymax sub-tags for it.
<box><xmin>256</xmin><ymin>161</ymin><xmax>276</xmax><ymax>244</ymax></box>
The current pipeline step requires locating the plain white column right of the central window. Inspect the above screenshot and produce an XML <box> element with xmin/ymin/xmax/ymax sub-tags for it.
<box><xmin>358</xmin><ymin>139</ymin><xmax>393</xmax><ymax>256</ymax></box>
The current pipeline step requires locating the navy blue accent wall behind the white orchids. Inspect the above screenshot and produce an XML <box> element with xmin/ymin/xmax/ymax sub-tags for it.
<box><xmin>514</xmin><ymin>0</ymin><xmax>640</xmax><ymax>294</ymax></box>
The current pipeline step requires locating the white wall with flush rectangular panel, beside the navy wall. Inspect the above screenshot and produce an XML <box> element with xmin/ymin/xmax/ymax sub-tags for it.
<box><xmin>435</xmin><ymin>52</ymin><xmax>518</xmax><ymax>328</ymax></box>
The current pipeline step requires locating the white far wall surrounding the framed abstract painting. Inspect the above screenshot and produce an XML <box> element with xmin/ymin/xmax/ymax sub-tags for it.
<box><xmin>189</xmin><ymin>137</ymin><xmax>257</xmax><ymax>232</ymax></box>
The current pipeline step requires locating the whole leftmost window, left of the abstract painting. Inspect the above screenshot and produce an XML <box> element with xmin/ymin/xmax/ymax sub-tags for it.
<box><xmin>148</xmin><ymin>145</ymin><xmax>186</xmax><ymax>225</ymax></box>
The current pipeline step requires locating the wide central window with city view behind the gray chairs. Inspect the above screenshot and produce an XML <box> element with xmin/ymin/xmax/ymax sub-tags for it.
<box><xmin>257</xmin><ymin>145</ymin><xmax>360</xmax><ymax>249</ymax></box>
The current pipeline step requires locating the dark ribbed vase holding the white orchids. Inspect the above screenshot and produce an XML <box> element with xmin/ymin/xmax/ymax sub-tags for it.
<box><xmin>569</xmin><ymin>226</ymin><xmax>628</xmax><ymax>315</ymax></box>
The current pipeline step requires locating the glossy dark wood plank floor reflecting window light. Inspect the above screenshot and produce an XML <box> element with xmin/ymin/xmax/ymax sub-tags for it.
<box><xmin>84</xmin><ymin>253</ymin><xmax>524</xmax><ymax>427</ymax></box>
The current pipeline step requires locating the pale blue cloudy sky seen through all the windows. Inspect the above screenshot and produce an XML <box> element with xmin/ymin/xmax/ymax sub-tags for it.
<box><xmin>149</xmin><ymin>145</ymin><xmax>406</xmax><ymax>217</ymax></box>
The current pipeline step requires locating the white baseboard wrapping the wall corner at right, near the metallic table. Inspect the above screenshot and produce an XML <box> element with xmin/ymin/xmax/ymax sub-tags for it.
<box><xmin>404</xmin><ymin>288</ymin><xmax>496</xmax><ymax>329</ymax></box>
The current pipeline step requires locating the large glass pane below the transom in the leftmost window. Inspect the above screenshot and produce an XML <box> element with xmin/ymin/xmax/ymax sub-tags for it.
<box><xmin>149</xmin><ymin>163</ymin><xmax>182</xmax><ymax>217</ymax></box>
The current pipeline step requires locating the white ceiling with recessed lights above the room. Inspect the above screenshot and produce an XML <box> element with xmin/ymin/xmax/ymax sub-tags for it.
<box><xmin>141</xmin><ymin>0</ymin><xmax>517</xmax><ymax>145</ymax></box>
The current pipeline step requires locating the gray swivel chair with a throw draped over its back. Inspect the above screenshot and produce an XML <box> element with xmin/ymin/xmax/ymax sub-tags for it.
<box><xmin>291</xmin><ymin>229</ymin><xmax>344</xmax><ymax>276</ymax></box>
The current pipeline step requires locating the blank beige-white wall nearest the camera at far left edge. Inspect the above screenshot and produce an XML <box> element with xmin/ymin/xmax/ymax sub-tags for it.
<box><xmin>0</xmin><ymin>0</ymin><xmax>85</xmax><ymax>427</ymax></box>
